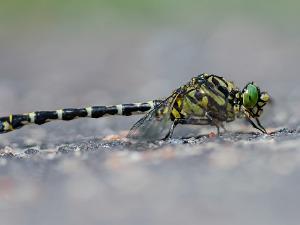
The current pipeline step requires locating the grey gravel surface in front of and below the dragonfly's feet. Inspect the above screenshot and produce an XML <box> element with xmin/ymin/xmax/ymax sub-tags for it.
<box><xmin>0</xmin><ymin>129</ymin><xmax>300</xmax><ymax>224</ymax></box>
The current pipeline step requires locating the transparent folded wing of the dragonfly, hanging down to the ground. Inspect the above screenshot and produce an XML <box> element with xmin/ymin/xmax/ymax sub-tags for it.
<box><xmin>127</xmin><ymin>92</ymin><xmax>178</xmax><ymax>141</ymax></box>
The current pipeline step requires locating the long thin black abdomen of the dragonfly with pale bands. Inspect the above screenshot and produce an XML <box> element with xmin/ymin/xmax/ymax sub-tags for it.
<box><xmin>0</xmin><ymin>100</ymin><xmax>160</xmax><ymax>133</ymax></box>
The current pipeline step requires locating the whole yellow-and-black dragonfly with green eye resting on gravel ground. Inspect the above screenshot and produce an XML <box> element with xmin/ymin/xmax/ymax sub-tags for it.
<box><xmin>0</xmin><ymin>73</ymin><xmax>270</xmax><ymax>140</ymax></box>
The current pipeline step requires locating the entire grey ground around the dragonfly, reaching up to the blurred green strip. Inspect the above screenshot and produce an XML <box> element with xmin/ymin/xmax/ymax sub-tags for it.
<box><xmin>0</xmin><ymin>6</ymin><xmax>300</xmax><ymax>225</ymax></box>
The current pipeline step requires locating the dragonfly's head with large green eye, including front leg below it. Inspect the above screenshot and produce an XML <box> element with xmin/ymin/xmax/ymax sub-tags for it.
<box><xmin>241</xmin><ymin>82</ymin><xmax>270</xmax><ymax>133</ymax></box>
